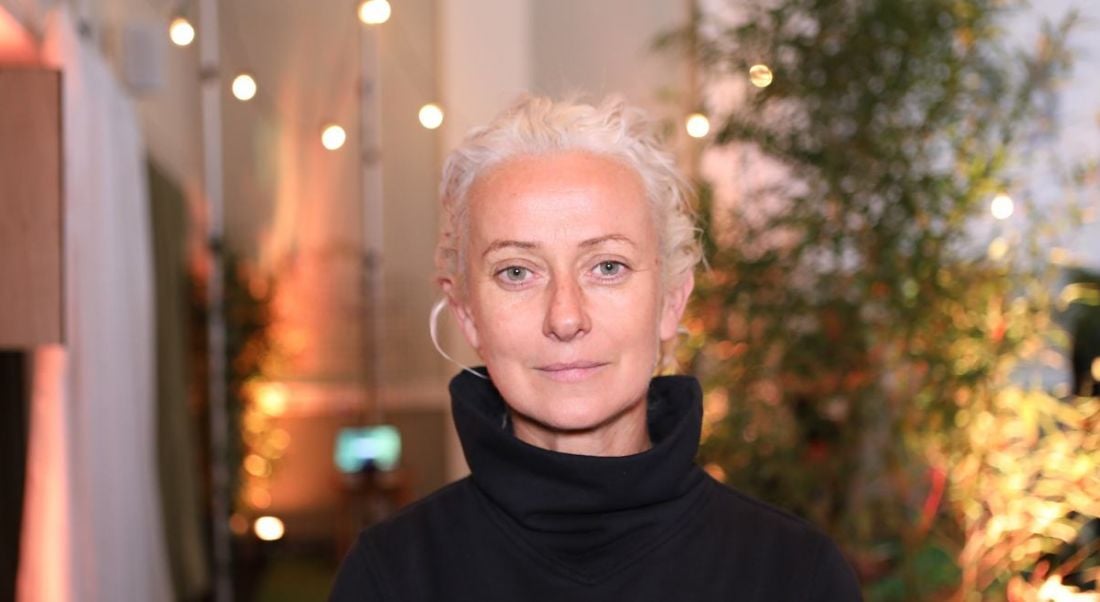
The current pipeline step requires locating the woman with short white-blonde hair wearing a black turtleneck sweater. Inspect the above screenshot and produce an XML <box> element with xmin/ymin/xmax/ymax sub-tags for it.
<box><xmin>331</xmin><ymin>98</ymin><xmax>859</xmax><ymax>602</ymax></box>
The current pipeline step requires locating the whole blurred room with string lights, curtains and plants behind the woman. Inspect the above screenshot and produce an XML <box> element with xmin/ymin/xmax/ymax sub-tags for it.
<box><xmin>0</xmin><ymin>0</ymin><xmax>1100</xmax><ymax>602</ymax></box>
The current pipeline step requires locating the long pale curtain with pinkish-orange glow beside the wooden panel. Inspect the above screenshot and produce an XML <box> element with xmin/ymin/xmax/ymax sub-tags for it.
<box><xmin>18</xmin><ymin>7</ymin><xmax>172</xmax><ymax>602</ymax></box>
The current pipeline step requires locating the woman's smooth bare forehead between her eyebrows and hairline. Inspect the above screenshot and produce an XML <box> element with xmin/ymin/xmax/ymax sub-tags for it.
<box><xmin>468</xmin><ymin>151</ymin><xmax>656</xmax><ymax>244</ymax></box>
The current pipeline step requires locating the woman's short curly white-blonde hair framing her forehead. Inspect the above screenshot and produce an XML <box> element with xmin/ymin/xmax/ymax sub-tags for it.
<box><xmin>436</xmin><ymin>95</ymin><xmax>702</xmax><ymax>294</ymax></box>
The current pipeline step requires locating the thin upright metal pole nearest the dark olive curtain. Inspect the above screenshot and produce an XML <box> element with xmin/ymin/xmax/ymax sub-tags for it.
<box><xmin>198</xmin><ymin>0</ymin><xmax>233</xmax><ymax>602</ymax></box>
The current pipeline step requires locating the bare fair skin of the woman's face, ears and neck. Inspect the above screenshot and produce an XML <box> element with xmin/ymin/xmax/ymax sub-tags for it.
<box><xmin>441</xmin><ymin>151</ymin><xmax>693</xmax><ymax>456</ymax></box>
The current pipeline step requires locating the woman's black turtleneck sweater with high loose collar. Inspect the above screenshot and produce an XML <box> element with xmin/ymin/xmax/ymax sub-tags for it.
<box><xmin>330</xmin><ymin>372</ymin><xmax>860</xmax><ymax>602</ymax></box>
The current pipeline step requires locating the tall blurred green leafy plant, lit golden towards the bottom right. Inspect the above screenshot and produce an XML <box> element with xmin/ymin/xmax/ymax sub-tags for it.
<box><xmin>681</xmin><ymin>0</ymin><xmax>1100</xmax><ymax>600</ymax></box>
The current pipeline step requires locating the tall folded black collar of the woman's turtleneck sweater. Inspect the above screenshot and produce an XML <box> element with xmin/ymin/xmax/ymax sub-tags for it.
<box><xmin>450</xmin><ymin>372</ymin><xmax>705</xmax><ymax>582</ymax></box>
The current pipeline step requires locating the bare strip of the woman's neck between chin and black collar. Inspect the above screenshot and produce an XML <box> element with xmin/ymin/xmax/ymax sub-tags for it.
<box><xmin>509</xmin><ymin>397</ymin><xmax>652</xmax><ymax>457</ymax></box>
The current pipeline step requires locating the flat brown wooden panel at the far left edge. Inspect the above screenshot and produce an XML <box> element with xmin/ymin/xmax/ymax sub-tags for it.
<box><xmin>0</xmin><ymin>68</ymin><xmax>63</xmax><ymax>348</ymax></box>
